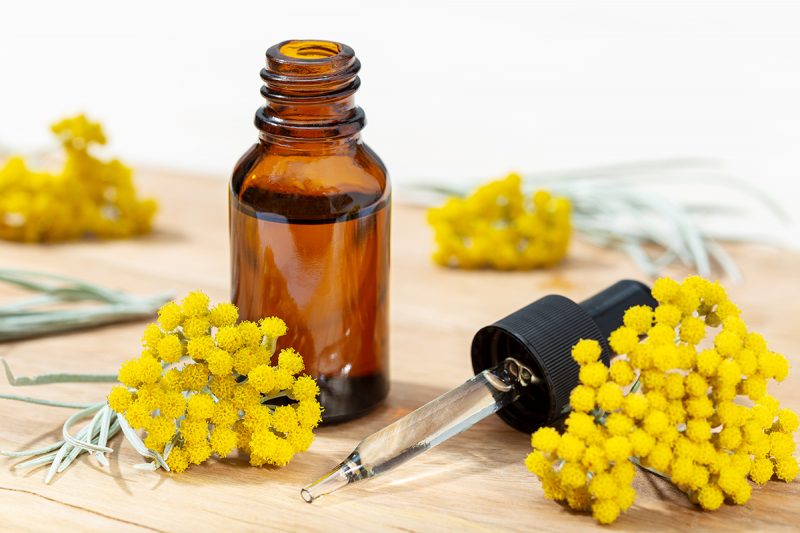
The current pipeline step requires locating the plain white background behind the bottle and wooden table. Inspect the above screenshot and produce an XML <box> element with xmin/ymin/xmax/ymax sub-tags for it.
<box><xmin>0</xmin><ymin>0</ymin><xmax>800</xmax><ymax>227</ymax></box>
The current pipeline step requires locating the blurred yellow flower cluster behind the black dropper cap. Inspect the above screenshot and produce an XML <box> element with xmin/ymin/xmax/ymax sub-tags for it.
<box><xmin>428</xmin><ymin>174</ymin><xmax>571</xmax><ymax>270</ymax></box>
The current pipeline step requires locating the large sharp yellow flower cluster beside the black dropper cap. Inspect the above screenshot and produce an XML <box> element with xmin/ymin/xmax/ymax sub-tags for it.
<box><xmin>526</xmin><ymin>276</ymin><xmax>798</xmax><ymax>524</ymax></box>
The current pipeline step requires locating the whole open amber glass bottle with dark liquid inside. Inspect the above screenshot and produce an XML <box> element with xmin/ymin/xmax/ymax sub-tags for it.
<box><xmin>230</xmin><ymin>41</ymin><xmax>390</xmax><ymax>422</ymax></box>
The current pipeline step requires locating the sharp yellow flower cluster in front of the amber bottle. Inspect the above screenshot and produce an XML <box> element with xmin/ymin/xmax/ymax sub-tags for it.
<box><xmin>108</xmin><ymin>292</ymin><xmax>322</xmax><ymax>472</ymax></box>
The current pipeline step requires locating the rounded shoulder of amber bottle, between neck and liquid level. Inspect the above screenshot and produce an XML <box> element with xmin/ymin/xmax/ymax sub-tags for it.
<box><xmin>231</xmin><ymin>143</ymin><xmax>390</xmax><ymax>220</ymax></box>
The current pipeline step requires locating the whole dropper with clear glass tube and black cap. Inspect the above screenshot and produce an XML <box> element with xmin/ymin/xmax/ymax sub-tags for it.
<box><xmin>300</xmin><ymin>280</ymin><xmax>655</xmax><ymax>503</ymax></box>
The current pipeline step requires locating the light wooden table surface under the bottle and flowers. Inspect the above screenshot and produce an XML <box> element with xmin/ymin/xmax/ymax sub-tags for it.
<box><xmin>0</xmin><ymin>169</ymin><xmax>800</xmax><ymax>531</ymax></box>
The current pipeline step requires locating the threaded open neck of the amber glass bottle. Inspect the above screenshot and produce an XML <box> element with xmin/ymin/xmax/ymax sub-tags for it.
<box><xmin>255</xmin><ymin>41</ymin><xmax>366</xmax><ymax>143</ymax></box>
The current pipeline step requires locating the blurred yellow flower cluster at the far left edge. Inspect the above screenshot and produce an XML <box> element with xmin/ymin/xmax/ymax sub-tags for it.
<box><xmin>0</xmin><ymin>115</ymin><xmax>156</xmax><ymax>242</ymax></box>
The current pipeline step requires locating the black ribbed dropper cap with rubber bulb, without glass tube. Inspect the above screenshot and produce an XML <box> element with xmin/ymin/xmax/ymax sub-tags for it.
<box><xmin>472</xmin><ymin>280</ymin><xmax>656</xmax><ymax>433</ymax></box>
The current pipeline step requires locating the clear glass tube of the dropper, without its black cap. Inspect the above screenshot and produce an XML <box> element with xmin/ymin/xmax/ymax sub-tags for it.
<box><xmin>300</xmin><ymin>358</ymin><xmax>536</xmax><ymax>503</ymax></box>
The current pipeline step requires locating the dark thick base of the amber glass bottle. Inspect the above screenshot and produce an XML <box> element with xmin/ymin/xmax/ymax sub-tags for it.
<box><xmin>317</xmin><ymin>374</ymin><xmax>389</xmax><ymax>425</ymax></box>
